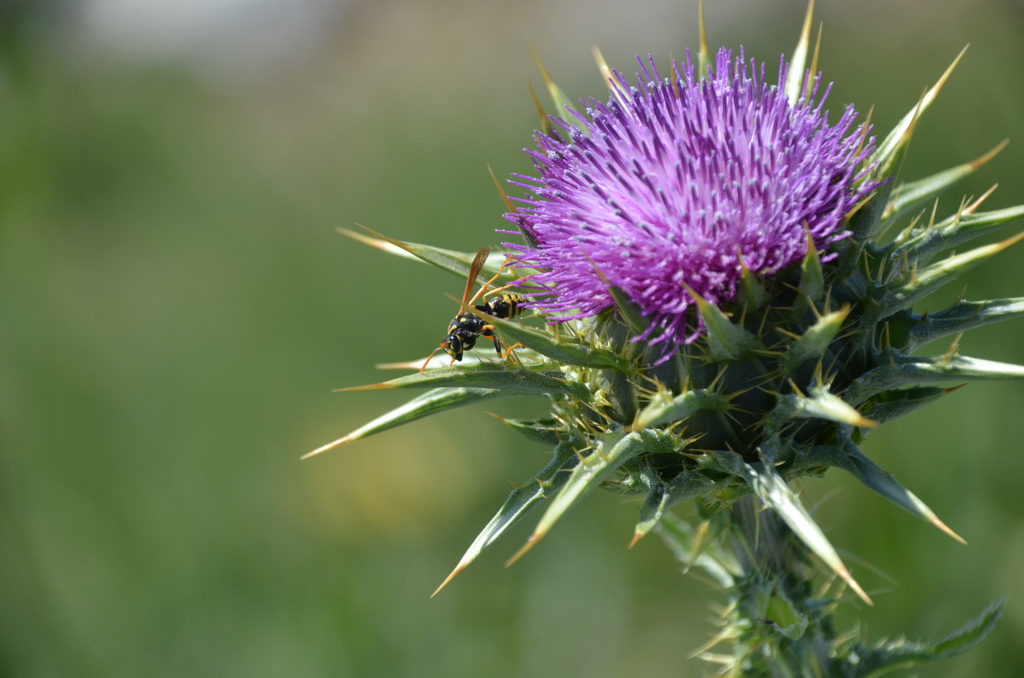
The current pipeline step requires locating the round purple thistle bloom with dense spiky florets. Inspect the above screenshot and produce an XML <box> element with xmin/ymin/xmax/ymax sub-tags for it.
<box><xmin>506</xmin><ymin>49</ymin><xmax>874</xmax><ymax>354</ymax></box>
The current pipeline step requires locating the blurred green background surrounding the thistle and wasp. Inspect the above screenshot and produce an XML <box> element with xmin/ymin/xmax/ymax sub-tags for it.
<box><xmin>0</xmin><ymin>0</ymin><xmax>1024</xmax><ymax>678</ymax></box>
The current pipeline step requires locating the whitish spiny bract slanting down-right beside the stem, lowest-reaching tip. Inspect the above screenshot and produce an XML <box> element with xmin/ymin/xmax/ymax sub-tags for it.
<box><xmin>744</xmin><ymin>464</ymin><xmax>873</xmax><ymax>605</ymax></box>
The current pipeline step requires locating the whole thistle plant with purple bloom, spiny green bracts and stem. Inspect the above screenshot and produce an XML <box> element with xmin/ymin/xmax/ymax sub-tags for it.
<box><xmin>307</xmin><ymin>2</ymin><xmax>1024</xmax><ymax>676</ymax></box>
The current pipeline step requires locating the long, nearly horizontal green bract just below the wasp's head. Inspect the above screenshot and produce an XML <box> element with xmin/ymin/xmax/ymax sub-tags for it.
<box><xmin>338</xmin><ymin>363</ymin><xmax>591</xmax><ymax>401</ymax></box>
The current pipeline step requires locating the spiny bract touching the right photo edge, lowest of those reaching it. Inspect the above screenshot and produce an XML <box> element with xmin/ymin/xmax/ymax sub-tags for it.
<box><xmin>843</xmin><ymin>350</ymin><xmax>1024</xmax><ymax>407</ymax></box>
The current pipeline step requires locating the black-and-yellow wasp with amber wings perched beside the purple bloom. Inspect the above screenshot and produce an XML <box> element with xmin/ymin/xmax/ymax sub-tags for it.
<box><xmin>420</xmin><ymin>247</ymin><xmax>526</xmax><ymax>372</ymax></box>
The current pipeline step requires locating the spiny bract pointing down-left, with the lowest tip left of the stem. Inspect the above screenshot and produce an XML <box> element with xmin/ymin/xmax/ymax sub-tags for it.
<box><xmin>431</xmin><ymin>440</ymin><xmax>579</xmax><ymax>597</ymax></box>
